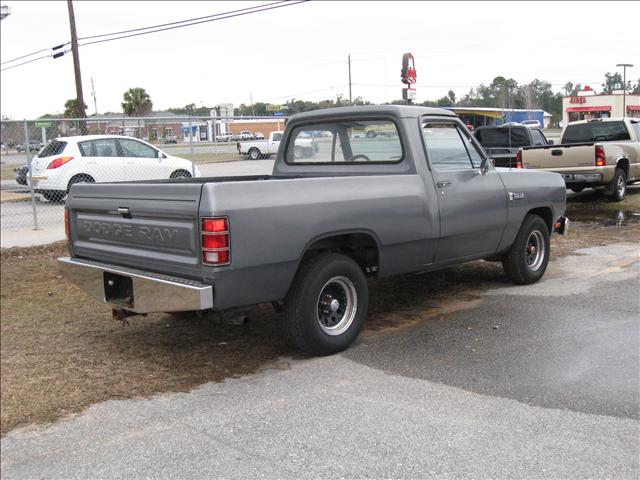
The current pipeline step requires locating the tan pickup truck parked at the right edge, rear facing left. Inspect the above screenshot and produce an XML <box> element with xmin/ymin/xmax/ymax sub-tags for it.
<box><xmin>516</xmin><ymin>118</ymin><xmax>640</xmax><ymax>201</ymax></box>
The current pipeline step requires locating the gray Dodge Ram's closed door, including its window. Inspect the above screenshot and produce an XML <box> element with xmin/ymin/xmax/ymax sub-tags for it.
<box><xmin>422</xmin><ymin>119</ymin><xmax>507</xmax><ymax>263</ymax></box>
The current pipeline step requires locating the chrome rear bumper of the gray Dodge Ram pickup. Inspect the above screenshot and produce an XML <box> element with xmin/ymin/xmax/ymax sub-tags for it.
<box><xmin>58</xmin><ymin>257</ymin><xmax>213</xmax><ymax>313</ymax></box>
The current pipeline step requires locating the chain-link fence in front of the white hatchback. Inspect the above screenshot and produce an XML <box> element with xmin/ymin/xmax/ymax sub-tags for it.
<box><xmin>0</xmin><ymin>115</ymin><xmax>286</xmax><ymax>236</ymax></box>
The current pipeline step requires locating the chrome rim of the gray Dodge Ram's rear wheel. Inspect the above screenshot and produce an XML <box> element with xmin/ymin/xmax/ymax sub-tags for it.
<box><xmin>316</xmin><ymin>276</ymin><xmax>358</xmax><ymax>336</ymax></box>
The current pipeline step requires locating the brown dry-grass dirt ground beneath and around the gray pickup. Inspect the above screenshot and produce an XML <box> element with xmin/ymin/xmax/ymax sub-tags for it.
<box><xmin>0</xmin><ymin>201</ymin><xmax>640</xmax><ymax>435</ymax></box>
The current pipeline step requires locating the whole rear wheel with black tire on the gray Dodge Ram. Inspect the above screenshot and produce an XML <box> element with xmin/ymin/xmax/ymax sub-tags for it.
<box><xmin>284</xmin><ymin>253</ymin><xmax>369</xmax><ymax>355</ymax></box>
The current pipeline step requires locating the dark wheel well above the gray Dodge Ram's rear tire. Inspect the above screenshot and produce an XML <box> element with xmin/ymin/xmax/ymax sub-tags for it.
<box><xmin>303</xmin><ymin>233</ymin><xmax>380</xmax><ymax>277</ymax></box>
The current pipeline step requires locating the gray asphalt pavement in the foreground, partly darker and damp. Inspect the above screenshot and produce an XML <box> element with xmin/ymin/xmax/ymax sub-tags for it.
<box><xmin>1</xmin><ymin>244</ymin><xmax>640</xmax><ymax>479</ymax></box>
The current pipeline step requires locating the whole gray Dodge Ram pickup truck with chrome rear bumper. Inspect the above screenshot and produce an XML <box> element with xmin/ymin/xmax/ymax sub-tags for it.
<box><xmin>59</xmin><ymin>106</ymin><xmax>566</xmax><ymax>355</ymax></box>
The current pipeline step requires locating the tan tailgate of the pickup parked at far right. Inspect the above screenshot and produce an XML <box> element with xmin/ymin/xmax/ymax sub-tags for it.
<box><xmin>522</xmin><ymin>144</ymin><xmax>595</xmax><ymax>171</ymax></box>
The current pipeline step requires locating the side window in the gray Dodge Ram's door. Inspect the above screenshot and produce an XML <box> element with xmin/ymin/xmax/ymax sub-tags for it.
<box><xmin>422</xmin><ymin>122</ymin><xmax>478</xmax><ymax>170</ymax></box>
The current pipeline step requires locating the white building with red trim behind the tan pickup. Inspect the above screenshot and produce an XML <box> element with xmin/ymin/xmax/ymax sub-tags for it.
<box><xmin>562</xmin><ymin>87</ymin><xmax>640</xmax><ymax>125</ymax></box>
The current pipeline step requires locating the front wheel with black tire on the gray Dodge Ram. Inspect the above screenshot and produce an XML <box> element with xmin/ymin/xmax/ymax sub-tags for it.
<box><xmin>502</xmin><ymin>214</ymin><xmax>551</xmax><ymax>285</ymax></box>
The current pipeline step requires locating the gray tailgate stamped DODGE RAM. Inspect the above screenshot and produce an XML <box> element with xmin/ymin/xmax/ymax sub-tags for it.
<box><xmin>66</xmin><ymin>182</ymin><xmax>202</xmax><ymax>279</ymax></box>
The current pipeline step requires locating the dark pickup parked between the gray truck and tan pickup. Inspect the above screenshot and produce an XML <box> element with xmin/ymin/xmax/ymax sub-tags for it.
<box><xmin>474</xmin><ymin>123</ymin><xmax>553</xmax><ymax>168</ymax></box>
